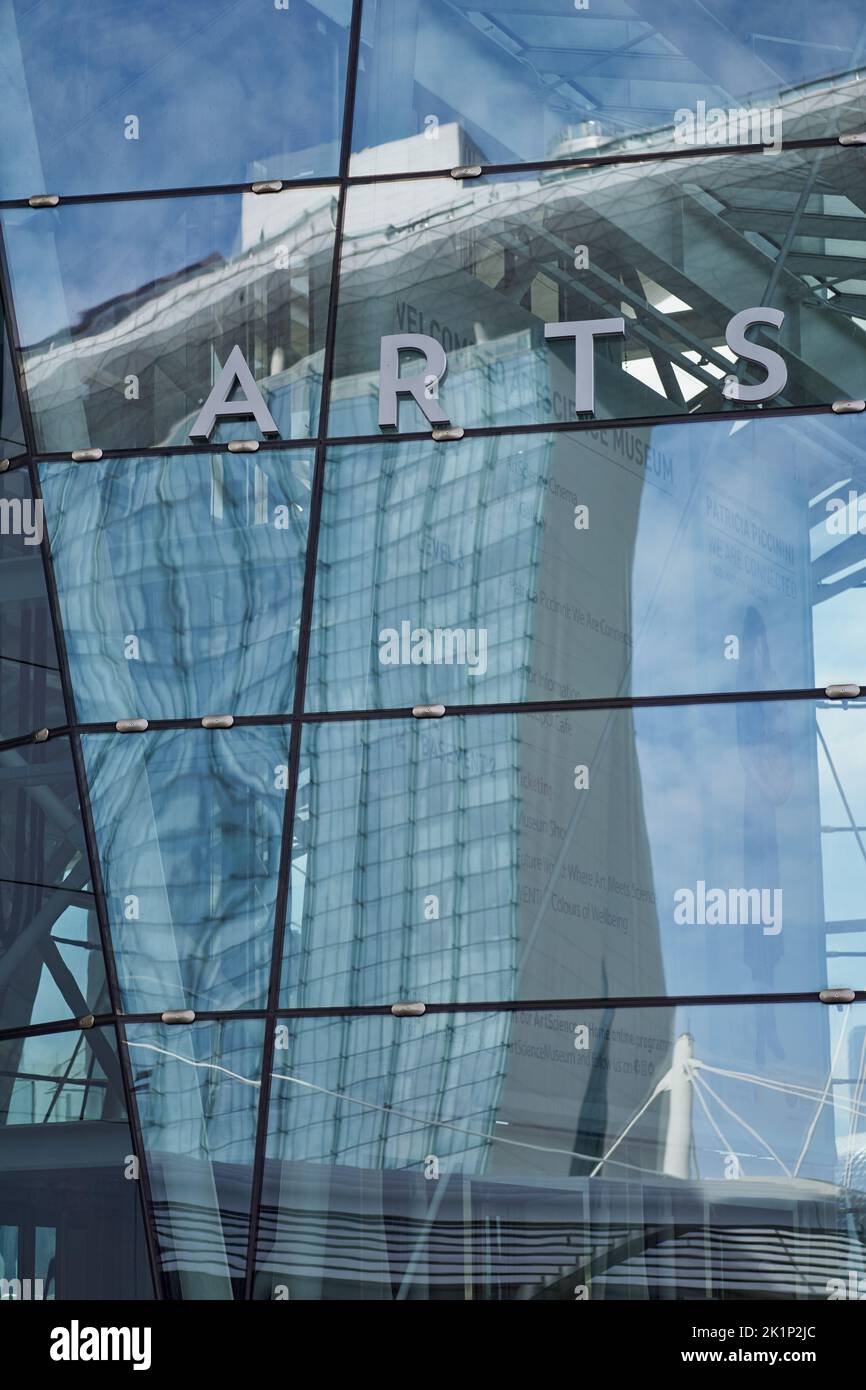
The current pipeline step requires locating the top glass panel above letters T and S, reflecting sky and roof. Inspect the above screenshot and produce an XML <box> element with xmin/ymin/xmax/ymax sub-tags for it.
<box><xmin>352</xmin><ymin>0</ymin><xmax>866</xmax><ymax>174</ymax></box>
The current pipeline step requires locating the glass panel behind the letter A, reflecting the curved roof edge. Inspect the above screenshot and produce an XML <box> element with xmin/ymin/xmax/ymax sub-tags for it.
<box><xmin>3</xmin><ymin>189</ymin><xmax>334</xmax><ymax>452</ymax></box>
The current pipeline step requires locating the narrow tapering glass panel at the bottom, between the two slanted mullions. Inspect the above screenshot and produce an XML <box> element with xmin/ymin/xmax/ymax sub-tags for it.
<box><xmin>126</xmin><ymin>1019</ymin><xmax>264</xmax><ymax>1298</ymax></box>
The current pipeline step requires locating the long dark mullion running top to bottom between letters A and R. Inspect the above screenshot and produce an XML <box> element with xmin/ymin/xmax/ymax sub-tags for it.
<box><xmin>243</xmin><ymin>0</ymin><xmax>361</xmax><ymax>1301</ymax></box>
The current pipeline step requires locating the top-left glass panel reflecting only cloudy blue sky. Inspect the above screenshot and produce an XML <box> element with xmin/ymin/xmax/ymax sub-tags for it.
<box><xmin>0</xmin><ymin>0</ymin><xmax>352</xmax><ymax>197</ymax></box>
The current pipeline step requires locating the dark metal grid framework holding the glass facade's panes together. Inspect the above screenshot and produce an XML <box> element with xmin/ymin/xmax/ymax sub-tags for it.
<box><xmin>0</xmin><ymin>0</ymin><xmax>866</xmax><ymax>1300</ymax></box>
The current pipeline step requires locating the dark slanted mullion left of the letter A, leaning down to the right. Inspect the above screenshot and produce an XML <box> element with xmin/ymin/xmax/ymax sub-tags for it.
<box><xmin>0</xmin><ymin>228</ymin><xmax>164</xmax><ymax>1301</ymax></box>
